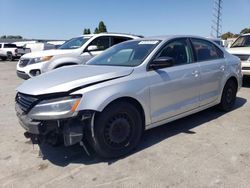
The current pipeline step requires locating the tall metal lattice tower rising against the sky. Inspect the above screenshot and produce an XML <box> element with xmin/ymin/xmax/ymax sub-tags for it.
<box><xmin>211</xmin><ymin>0</ymin><xmax>222</xmax><ymax>38</ymax></box>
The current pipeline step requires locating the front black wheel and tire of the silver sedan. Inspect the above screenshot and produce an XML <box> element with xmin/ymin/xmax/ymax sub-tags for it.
<box><xmin>88</xmin><ymin>102</ymin><xmax>143</xmax><ymax>158</ymax></box>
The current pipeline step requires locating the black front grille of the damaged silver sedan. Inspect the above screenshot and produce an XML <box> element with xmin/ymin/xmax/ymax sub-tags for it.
<box><xmin>16</xmin><ymin>93</ymin><xmax>38</xmax><ymax>113</ymax></box>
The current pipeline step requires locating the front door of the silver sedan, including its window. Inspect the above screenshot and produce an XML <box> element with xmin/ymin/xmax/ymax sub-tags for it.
<box><xmin>148</xmin><ymin>38</ymin><xmax>200</xmax><ymax>123</ymax></box>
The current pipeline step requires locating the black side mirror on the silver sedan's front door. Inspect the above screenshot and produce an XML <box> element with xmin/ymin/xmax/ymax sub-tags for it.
<box><xmin>149</xmin><ymin>56</ymin><xmax>174</xmax><ymax>70</ymax></box>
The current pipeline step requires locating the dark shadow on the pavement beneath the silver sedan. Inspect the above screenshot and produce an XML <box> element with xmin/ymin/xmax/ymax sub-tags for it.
<box><xmin>39</xmin><ymin>97</ymin><xmax>247</xmax><ymax>166</ymax></box>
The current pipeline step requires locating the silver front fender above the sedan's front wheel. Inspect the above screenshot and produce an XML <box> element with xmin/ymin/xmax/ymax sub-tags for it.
<box><xmin>71</xmin><ymin>77</ymin><xmax>151</xmax><ymax>125</ymax></box>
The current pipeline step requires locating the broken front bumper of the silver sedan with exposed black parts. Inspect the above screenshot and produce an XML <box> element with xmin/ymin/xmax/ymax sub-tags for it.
<box><xmin>16</xmin><ymin>104</ymin><xmax>92</xmax><ymax>146</ymax></box>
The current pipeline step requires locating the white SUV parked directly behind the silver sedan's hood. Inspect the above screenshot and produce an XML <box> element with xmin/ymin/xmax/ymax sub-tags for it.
<box><xmin>17</xmin><ymin>33</ymin><xmax>140</xmax><ymax>79</ymax></box>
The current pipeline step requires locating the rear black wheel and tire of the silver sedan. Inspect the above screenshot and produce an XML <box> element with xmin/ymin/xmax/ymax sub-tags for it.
<box><xmin>219</xmin><ymin>80</ymin><xmax>237</xmax><ymax>112</ymax></box>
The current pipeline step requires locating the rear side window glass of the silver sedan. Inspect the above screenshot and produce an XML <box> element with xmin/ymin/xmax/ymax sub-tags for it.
<box><xmin>191</xmin><ymin>39</ymin><xmax>223</xmax><ymax>61</ymax></box>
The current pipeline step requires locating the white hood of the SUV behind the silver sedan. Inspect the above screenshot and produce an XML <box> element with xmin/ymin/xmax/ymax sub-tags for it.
<box><xmin>22</xmin><ymin>49</ymin><xmax>72</xmax><ymax>58</ymax></box>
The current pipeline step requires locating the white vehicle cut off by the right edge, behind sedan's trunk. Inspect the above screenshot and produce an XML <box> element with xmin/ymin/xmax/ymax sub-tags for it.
<box><xmin>227</xmin><ymin>33</ymin><xmax>250</xmax><ymax>76</ymax></box>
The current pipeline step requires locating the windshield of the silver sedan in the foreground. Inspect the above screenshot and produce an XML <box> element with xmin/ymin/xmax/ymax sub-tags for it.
<box><xmin>87</xmin><ymin>40</ymin><xmax>159</xmax><ymax>67</ymax></box>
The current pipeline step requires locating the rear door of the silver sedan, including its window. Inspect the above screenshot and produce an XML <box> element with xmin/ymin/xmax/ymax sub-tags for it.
<box><xmin>191</xmin><ymin>38</ymin><xmax>226</xmax><ymax>106</ymax></box>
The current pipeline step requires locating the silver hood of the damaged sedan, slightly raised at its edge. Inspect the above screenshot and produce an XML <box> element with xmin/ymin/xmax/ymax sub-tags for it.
<box><xmin>17</xmin><ymin>65</ymin><xmax>133</xmax><ymax>95</ymax></box>
